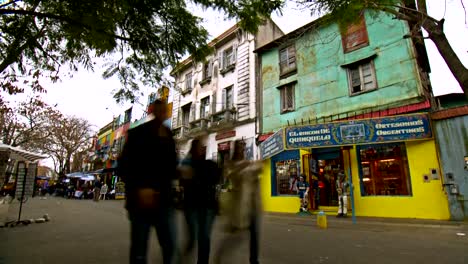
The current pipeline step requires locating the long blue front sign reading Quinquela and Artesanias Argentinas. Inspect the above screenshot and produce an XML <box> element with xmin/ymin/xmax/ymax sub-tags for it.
<box><xmin>285</xmin><ymin>114</ymin><xmax>432</xmax><ymax>149</ymax></box>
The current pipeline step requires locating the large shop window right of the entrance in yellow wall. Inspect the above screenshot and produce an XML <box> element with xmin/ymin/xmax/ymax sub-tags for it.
<box><xmin>358</xmin><ymin>143</ymin><xmax>412</xmax><ymax>196</ymax></box>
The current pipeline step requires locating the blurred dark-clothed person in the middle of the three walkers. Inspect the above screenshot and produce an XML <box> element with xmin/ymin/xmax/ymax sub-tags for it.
<box><xmin>180</xmin><ymin>139</ymin><xmax>221</xmax><ymax>264</ymax></box>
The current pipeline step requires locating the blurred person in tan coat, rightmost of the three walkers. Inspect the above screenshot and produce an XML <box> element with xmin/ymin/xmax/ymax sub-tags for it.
<box><xmin>215</xmin><ymin>140</ymin><xmax>263</xmax><ymax>264</ymax></box>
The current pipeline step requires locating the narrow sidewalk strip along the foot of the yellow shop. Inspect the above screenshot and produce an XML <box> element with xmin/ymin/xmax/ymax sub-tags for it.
<box><xmin>264</xmin><ymin>212</ymin><xmax>468</xmax><ymax>231</ymax></box>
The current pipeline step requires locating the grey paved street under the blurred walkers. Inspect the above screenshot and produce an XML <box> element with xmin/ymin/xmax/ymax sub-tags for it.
<box><xmin>0</xmin><ymin>198</ymin><xmax>468</xmax><ymax>264</ymax></box>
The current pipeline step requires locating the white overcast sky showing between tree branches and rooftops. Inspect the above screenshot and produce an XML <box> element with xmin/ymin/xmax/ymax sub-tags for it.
<box><xmin>35</xmin><ymin>0</ymin><xmax>468</xmax><ymax>127</ymax></box>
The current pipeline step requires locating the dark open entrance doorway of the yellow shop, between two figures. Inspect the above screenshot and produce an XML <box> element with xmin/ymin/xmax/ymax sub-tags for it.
<box><xmin>312</xmin><ymin>148</ymin><xmax>344</xmax><ymax>206</ymax></box>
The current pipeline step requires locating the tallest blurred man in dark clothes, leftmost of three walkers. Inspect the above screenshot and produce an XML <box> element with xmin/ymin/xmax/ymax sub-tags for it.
<box><xmin>118</xmin><ymin>100</ymin><xmax>177</xmax><ymax>264</ymax></box>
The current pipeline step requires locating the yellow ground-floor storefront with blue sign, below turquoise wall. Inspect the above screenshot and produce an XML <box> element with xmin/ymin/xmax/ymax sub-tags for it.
<box><xmin>260</xmin><ymin>113</ymin><xmax>450</xmax><ymax>219</ymax></box>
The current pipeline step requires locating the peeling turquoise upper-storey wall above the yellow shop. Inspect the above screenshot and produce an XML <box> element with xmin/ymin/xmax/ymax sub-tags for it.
<box><xmin>261</xmin><ymin>11</ymin><xmax>424</xmax><ymax>133</ymax></box>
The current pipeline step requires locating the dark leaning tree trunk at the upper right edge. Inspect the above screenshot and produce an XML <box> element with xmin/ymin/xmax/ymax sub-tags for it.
<box><xmin>423</xmin><ymin>20</ymin><xmax>468</xmax><ymax>98</ymax></box>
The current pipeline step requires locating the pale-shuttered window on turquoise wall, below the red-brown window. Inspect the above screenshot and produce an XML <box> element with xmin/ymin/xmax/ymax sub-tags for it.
<box><xmin>347</xmin><ymin>61</ymin><xmax>377</xmax><ymax>95</ymax></box>
